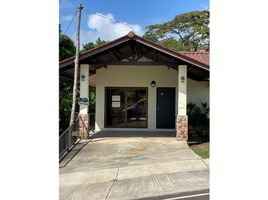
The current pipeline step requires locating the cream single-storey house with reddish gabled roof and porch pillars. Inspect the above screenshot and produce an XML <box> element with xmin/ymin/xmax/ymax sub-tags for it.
<box><xmin>59</xmin><ymin>32</ymin><xmax>209</xmax><ymax>140</ymax></box>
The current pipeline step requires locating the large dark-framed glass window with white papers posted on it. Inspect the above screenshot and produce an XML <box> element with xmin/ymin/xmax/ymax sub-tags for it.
<box><xmin>105</xmin><ymin>87</ymin><xmax>148</xmax><ymax>128</ymax></box>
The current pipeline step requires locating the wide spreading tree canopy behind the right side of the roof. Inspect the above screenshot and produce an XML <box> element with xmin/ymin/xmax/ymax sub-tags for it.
<box><xmin>144</xmin><ymin>11</ymin><xmax>209</xmax><ymax>51</ymax></box>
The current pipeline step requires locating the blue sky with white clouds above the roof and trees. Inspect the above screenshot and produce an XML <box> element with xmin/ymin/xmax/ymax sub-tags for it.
<box><xmin>59</xmin><ymin>0</ymin><xmax>209</xmax><ymax>44</ymax></box>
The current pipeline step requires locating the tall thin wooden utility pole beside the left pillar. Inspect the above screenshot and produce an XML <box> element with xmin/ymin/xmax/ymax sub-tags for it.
<box><xmin>70</xmin><ymin>4</ymin><xmax>83</xmax><ymax>126</ymax></box>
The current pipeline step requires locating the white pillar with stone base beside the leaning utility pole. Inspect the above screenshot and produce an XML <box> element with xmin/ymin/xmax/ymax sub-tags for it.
<box><xmin>79</xmin><ymin>64</ymin><xmax>89</xmax><ymax>138</ymax></box>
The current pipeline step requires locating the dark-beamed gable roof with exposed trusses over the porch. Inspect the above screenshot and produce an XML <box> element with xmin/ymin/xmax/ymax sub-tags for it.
<box><xmin>59</xmin><ymin>32</ymin><xmax>209</xmax><ymax>81</ymax></box>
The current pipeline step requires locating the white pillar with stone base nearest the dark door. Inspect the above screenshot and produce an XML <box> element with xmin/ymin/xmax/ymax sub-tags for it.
<box><xmin>176</xmin><ymin>65</ymin><xmax>188</xmax><ymax>141</ymax></box>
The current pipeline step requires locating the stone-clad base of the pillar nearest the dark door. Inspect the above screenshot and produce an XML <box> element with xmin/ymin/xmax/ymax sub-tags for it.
<box><xmin>176</xmin><ymin>115</ymin><xmax>188</xmax><ymax>141</ymax></box>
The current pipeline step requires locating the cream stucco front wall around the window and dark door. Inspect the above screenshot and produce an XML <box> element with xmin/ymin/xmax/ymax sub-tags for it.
<box><xmin>95</xmin><ymin>65</ymin><xmax>208</xmax><ymax>131</ymax></box>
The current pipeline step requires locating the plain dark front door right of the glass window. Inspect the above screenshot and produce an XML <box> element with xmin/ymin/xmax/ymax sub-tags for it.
<box><xmin>156</xmin><ymin>87</ymin><xmax>175</xmax><ymax>129</ymax></box>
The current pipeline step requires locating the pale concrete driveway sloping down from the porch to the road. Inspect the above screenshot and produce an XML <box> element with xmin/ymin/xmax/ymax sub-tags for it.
<box><xmin>59</xmin><ymin>131</ymin><xmax>209</xmax><ymax>200</ymax></box>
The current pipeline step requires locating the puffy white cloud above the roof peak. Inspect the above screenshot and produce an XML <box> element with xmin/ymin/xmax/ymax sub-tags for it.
<box><xmin>81</xmin><ymin>13</ymin><xmax>144</xmax><ymax>44</ymax></box>
